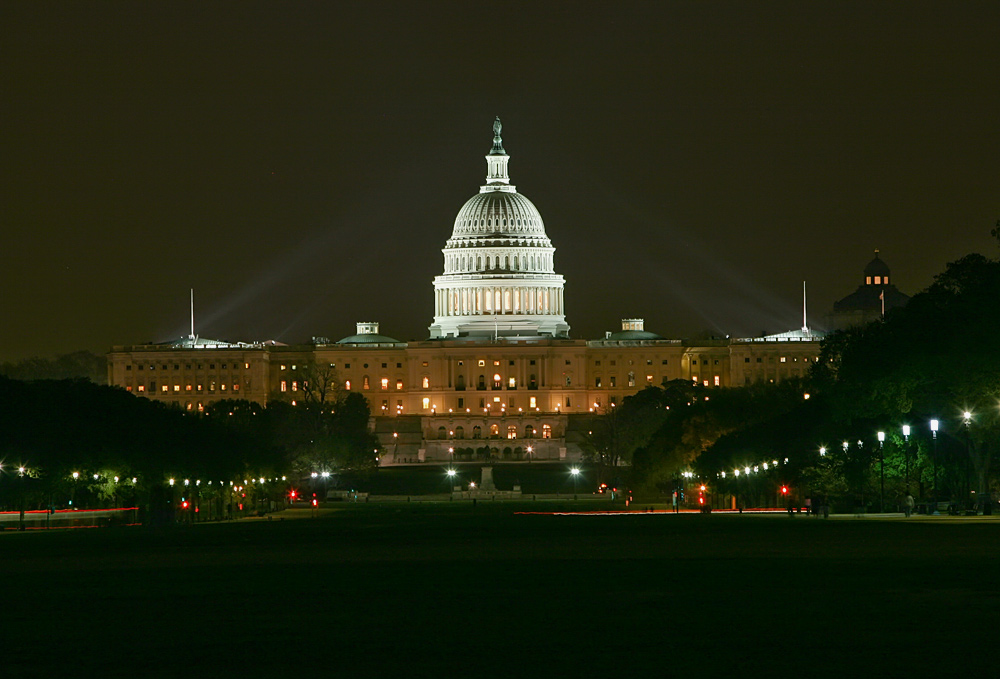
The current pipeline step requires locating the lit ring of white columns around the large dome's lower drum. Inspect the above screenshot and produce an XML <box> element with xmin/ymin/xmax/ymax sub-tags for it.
<box><xmin>435</xmin><ymin>286</ymin><xmax>563</xmax><ymax>316</ymax></box>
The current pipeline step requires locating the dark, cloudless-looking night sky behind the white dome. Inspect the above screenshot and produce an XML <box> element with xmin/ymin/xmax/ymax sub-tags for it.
<box><xmin>0</xmin><ymin>0</ymin><xmax>1000</xmax><ymax>360</ymax></box>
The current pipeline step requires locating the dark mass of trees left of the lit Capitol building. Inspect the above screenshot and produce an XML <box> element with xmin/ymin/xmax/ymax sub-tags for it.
<box><xmin>0</xmin><ymin>377</ymin><xmax>377</xmax><ymax>510</ymax></box>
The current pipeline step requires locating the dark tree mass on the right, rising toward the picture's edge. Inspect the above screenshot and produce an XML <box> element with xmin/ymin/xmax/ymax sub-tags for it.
<box><xmin>587</xmin><ymin>231</ymin><xmax>1000</xmax><ymax>509</ymax></box>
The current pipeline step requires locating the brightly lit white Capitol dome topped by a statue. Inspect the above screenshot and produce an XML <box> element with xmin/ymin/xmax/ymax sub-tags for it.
<box><xmin>430</xmin><ymin>118</ymin><xmax>569</xmax><ymax>338</ymax></box>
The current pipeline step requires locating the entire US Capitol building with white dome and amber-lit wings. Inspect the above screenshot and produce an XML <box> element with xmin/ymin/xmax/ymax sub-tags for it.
<box><xmin>108</xmin><ymin>119</ymin><xmax>900</xmax><ymax>465</ymax></box>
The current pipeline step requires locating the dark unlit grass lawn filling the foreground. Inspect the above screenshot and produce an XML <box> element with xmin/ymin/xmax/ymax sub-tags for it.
<box><xmin>0</xmin><ymin>504</ymin><xmax>1000</xmax><ymax>677</ymax></box>
